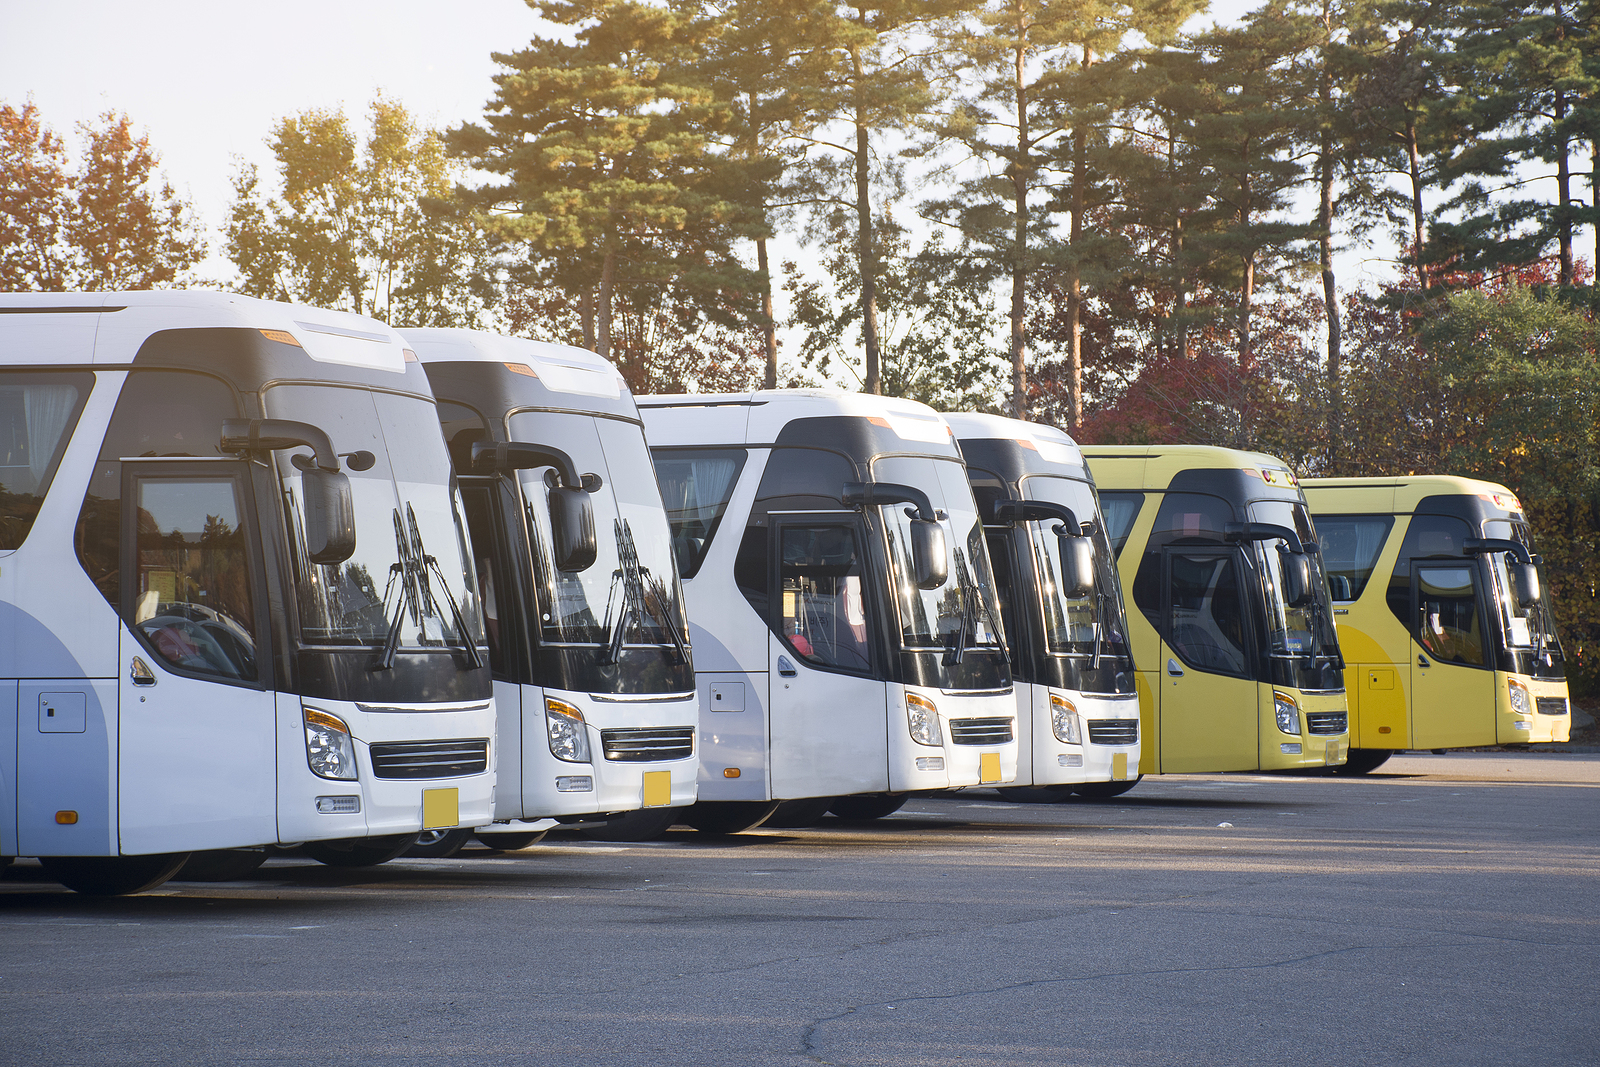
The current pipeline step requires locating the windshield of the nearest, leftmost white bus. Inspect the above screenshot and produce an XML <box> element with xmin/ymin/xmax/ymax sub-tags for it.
<box><xmin>262</xmin><ymin>384</ymin><xmax>483</xmax><ymax>653</ymax></box>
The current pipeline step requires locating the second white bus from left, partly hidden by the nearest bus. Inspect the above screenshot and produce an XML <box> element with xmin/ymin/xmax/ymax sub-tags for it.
<box><xmin>403</xmin><ymin>330</ymin><xmax>699</xmax><ymax>848</ymax></box>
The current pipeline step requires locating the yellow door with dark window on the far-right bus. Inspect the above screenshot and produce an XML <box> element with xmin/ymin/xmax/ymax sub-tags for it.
<box><xmin>1411</xmin><ymin>560</ymin><xmax>1496</xmax><ymax>749</ymax></box>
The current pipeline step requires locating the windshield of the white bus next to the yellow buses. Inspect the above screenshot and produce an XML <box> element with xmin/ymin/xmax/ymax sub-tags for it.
<box><xmin>1022</xmin><ymin>475</ymin><xmax>1130</xmax><ymax>670</ymax></box>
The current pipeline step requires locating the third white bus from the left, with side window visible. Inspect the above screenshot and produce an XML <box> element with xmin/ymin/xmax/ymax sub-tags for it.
<box><xmin>638</xmin><ymin>390</ymin><xmax>1018</xmax><ymax>833</ymax></box>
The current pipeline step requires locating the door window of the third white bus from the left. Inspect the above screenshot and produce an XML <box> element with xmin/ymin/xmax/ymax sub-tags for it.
<box><xmin>778</xmin><ymin>525</ymin><xmax>872</xmax><ymax>672</ymax></box>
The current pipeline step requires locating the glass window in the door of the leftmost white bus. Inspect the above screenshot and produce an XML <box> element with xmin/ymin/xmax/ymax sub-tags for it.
<box><xmin>128</xmin><ymin>475</ymin><xmax>256</xmax><ymax>681</ymax></box>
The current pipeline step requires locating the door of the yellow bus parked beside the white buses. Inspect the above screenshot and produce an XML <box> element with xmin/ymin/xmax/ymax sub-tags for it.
<box><xmin>1155</xmin><ymin>547</ymin><xmax>1261</xmax><ymax>774</ymax></box>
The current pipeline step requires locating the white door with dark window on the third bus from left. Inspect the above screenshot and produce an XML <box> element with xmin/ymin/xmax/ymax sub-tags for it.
<box><xmin>768</xmin><ymin>514</ymin><xmax>904</xmax><ymax>800</ymax></box>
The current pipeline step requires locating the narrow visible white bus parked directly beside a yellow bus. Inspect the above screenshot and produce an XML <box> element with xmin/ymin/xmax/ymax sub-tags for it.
<box><xmin>944</xmin><ymin>414</ymin><xmax>1139</xmax><ymax>801</ymax></box>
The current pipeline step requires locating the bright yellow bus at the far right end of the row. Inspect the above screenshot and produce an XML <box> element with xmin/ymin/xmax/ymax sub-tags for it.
<box><xmin>1306</xmin><ymin>477</ymin><xmax>1571</xmax><ymax>774</ymax></box>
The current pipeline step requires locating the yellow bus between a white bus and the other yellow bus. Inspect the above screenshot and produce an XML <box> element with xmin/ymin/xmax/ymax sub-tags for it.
<box><xmin>1083</xmin><ymin>445</ymin><xmax>1349</xmax><ymax>774</ymax></box>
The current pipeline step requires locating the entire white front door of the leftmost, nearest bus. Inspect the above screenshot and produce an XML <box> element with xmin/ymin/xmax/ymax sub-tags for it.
<box><xmin>117</xmin><ymin>461</ymin><xmax>275</xmax><ymax>854</ymax></box>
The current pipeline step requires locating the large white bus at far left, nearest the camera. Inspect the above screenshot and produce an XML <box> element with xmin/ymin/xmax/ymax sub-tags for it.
<box><xmin>0</xmin><ymin>291</ymin><xmax>494</xmax><ymax>894</ymax></box>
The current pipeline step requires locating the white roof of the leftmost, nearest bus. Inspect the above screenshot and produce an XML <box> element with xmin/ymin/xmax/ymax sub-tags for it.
<box><xmin>0</xmin><ymin>290</ymin><xmax>414</xmax><ymax>374</ymax></box>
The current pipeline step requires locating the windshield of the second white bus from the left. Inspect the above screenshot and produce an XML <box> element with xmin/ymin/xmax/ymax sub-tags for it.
<box><xmin>509</xmin><ymin>411</ymin><xmax>688</xmax><ymax>649</ymax></box>
